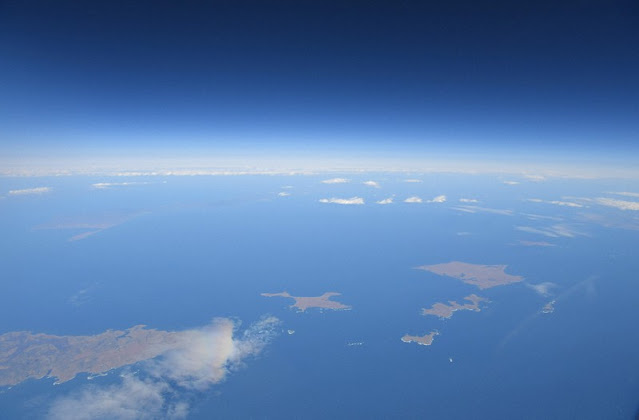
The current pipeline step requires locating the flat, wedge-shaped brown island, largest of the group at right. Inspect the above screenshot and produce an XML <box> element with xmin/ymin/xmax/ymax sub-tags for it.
<box><xmin>415</xmin><ymin>261</ymin><xmax>524</xmax><ymax>290</ymax></box>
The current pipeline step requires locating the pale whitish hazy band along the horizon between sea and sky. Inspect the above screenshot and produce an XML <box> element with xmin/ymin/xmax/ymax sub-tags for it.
<box><xmin>0</xmin><ymin>156</ymin><xmax>639</xmax><ymax>180</ymax></box>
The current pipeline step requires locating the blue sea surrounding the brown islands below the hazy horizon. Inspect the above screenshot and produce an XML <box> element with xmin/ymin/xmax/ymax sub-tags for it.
<box><xmin>0</xmin><ymin>174</ymin><xmax>639</xmax><ymax>419</ymax></box>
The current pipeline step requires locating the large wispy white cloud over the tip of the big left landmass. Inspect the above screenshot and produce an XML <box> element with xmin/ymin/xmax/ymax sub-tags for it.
<box><xmin>48</xmin><ymin>317</ymin><xmax>279</xmax><ymax>420</ymax></box>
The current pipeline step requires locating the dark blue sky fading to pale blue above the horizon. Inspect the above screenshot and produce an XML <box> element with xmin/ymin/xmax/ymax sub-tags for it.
<box><xmin>0</xmin><ymin>0</ymin><xmax>639</xmax><ymax>161</ymax></box>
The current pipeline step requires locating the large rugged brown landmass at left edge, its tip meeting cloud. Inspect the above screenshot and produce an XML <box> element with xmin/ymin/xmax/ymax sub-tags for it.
<box><xmin>0</xmin><ymin>325</ymin><xmax>186</xmax><ymax>386</ymax></box>
